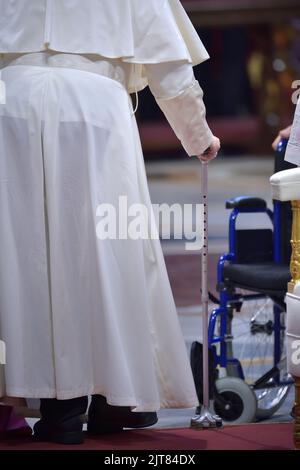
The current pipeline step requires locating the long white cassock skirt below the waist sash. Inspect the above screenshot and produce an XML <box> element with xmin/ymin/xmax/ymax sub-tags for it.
<box><xmin>0</xmin><ymin>65</ymin><xmax>197</xmax><ymax>411</ymax></box>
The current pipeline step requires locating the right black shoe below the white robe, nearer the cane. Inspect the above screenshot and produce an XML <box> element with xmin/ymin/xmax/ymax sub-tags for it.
<box><xmin>88</xmin><ymin>395</ymin><xmax>158</xmax><ymax>434</ymax></box>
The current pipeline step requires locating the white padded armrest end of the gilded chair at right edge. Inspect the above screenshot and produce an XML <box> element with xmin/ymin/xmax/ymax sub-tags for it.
<box><xmin>270</xmin><ymin>168</ymin><xmax>300</xmax><ymax>201</ymax></box>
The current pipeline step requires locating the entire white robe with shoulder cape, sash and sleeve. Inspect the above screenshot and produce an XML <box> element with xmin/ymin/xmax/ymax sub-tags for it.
<box><xmin>0</xmin><ymin>0</ymin><xmax>212</xmax><ymax>411</ymax></box>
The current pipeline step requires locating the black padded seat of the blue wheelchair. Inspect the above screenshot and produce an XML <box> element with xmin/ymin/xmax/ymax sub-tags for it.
<box><xmin>223</xmin><ymin>262</ymin><xmax>291</xmax><ymax>297</ymax></box>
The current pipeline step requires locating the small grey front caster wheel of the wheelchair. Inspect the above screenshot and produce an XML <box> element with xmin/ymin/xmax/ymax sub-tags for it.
<box><xmin>214</xmin><ymin>377</ymin><xmax>257</xmax><ymax>424</ymax></box>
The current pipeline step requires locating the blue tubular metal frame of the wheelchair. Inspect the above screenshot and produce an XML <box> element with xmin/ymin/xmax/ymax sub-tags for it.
<box><xmin>208</xmin><ymin>196</ymin><xmax>293</xmax><ymax>389</ymax></box>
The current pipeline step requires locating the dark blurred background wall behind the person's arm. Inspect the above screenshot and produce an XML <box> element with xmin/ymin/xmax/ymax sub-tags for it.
<box><xmin>137</xmin><ymin>0</ymin><xmax>300</xmax><ymax>159</ymax></box>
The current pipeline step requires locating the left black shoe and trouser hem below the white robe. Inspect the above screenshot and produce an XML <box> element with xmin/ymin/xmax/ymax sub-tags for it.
<box><xmin>33</xmin><ymin>397</ymin><xmax>88</xmax><ymax>444</ymax></box>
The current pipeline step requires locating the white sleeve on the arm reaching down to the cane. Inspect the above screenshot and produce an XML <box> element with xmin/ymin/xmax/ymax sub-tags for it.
<box><xmin>145</xmin><ymin>62</ymin><xmax>213</xmax><ymax>156</ymax></box>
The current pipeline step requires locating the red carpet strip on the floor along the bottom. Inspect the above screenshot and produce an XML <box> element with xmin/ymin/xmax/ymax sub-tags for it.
<box><xmin>0</xmin><ymin>423</ymin><xmax>294</xmax><ymax>451</ymax></box>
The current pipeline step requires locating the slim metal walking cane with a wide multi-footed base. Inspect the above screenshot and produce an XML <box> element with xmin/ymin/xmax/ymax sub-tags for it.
<box><xmin>191</xmin><ymin>162</ymin><xmax>222</xmax><ymax>429</ymax></box>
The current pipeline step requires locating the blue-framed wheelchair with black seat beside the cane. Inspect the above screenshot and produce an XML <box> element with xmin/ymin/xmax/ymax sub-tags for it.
<box><xmin>208</xmin><ymin>141</ymin><xmax>294</xmax><ymax>424</ymax></box>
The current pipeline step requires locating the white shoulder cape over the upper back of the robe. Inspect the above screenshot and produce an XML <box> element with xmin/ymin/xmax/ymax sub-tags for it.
<box><xmin>0</xmin><ymin>0</ymin><xmax>209</xmax><ymax>65</ymax></box>
